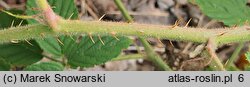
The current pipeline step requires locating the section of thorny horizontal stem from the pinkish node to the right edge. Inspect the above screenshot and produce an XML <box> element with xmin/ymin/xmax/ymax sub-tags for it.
<box><xmin>59</xmin><ymin>20</ymin><xmax>250</xmax><ymax>45</ymax></box>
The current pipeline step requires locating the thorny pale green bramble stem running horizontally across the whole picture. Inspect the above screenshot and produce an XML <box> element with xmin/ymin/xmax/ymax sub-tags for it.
<box><xmin>0</xmin><ymin>20</ymin><xmax>250</xmax><ymax>45</ymax></box>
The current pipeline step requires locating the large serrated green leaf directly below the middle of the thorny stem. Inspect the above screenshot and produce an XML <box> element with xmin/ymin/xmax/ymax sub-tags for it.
<box><xmin>61</xmin><ymin>36</ymin><xmax>132</xmax><ymax>67</ymax></box>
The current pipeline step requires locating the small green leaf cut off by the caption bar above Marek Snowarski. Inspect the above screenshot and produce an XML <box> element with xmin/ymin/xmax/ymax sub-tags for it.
<box><xmin>24</xmin><ymin>62</ymin><xmax>64</xmax><ymax>71</ymax></box>
